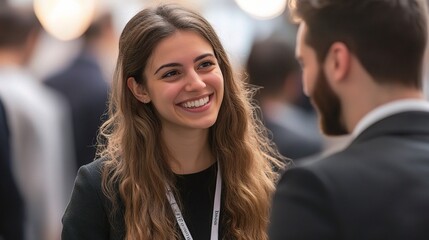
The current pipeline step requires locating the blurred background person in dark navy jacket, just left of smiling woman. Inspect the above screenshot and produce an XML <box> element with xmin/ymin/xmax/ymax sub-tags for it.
<box><xmin>44</xmin><ymin>12</ymin><xmax>117</xmax><ymax>171</ymax></box>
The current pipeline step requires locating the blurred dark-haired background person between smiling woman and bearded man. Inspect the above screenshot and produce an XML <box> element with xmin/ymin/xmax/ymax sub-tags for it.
<box><xmin>246</xmin><ymin>37</ymin><xmax>323</xmax><ymax>160</ymax></box>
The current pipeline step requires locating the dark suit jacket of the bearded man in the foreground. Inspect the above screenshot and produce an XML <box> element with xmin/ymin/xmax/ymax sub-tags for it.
<box><xmin>269</xmin><ymin>112</ymin><xmax>429</xmax><ymax>240</ymax></box>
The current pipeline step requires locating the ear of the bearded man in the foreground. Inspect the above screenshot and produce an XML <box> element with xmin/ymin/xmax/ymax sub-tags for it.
<box><xmin>323</xmin><ymin>42</ymin><xmax>351</xmax><ymax>82</ymax></box>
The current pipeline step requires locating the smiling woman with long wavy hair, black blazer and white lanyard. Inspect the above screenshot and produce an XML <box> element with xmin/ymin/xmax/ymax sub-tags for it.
<box><xmin>62</xmin><ymin>2</ymin><xmax>284</xmax><ymax>240</ymax></box>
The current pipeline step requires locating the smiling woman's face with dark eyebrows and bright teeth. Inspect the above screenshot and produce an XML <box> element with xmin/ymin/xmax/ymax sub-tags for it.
<box><xmin>144</xmin><ymin>31</ymin><xmax>224</xmax><ymax>132</ymax></box>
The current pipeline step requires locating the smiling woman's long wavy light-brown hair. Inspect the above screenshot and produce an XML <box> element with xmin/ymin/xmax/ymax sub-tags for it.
<box><xmin>98</xmin><ymin>4</ymin><xmax>284</xmax><ymax>240</ymax></box>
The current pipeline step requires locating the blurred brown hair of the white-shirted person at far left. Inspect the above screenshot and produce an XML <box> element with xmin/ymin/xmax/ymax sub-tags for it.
<box><xmin>0</xmin><ymin>4</ymin><xmax>41</xmax><ymax>48</ymax></box>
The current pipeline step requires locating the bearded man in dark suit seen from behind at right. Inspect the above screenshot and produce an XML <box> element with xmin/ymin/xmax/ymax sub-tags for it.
<box><xmin>269</xmin><ymin>0</ymin><xmax>429</xmax><ymax>240</ymax></box>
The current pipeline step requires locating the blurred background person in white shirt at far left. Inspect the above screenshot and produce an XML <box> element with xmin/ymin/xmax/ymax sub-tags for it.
<box><xmin>0</xmin><ymin>4</ymin><xmax>72</xmax><ymax>240</ymax></box>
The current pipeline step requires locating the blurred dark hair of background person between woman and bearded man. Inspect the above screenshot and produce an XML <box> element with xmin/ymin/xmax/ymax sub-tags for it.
<box><xmin>246</xmin><ymin>38</ymin><xmax>300</xmax><ymax>94</ymax></box>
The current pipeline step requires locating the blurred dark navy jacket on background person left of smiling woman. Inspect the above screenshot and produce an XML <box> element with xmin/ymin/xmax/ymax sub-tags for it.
<box><xmin>45</xmin><ymin>49</ymin><xmax>109</xmax><ymax>169</ymax></box>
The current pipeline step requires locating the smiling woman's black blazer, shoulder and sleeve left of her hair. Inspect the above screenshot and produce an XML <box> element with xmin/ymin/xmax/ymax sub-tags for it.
<box><xmin>61</xmin><ymin>159</ymin><xmax>125</xmax><ymax>240</ymax></box>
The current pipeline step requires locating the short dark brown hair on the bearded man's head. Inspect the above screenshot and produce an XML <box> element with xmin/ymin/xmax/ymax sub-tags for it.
<box><xmin>289</xmin><ymin>0</ymin><xmax>427</xmax><ymax>88</ymax></box>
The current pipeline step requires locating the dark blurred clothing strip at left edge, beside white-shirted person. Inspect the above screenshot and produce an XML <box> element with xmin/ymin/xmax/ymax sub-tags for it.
<box><xmin>0</xmin><ymin>98</ymin><xmax>24</xmax><ymax>240</ymax></box>
